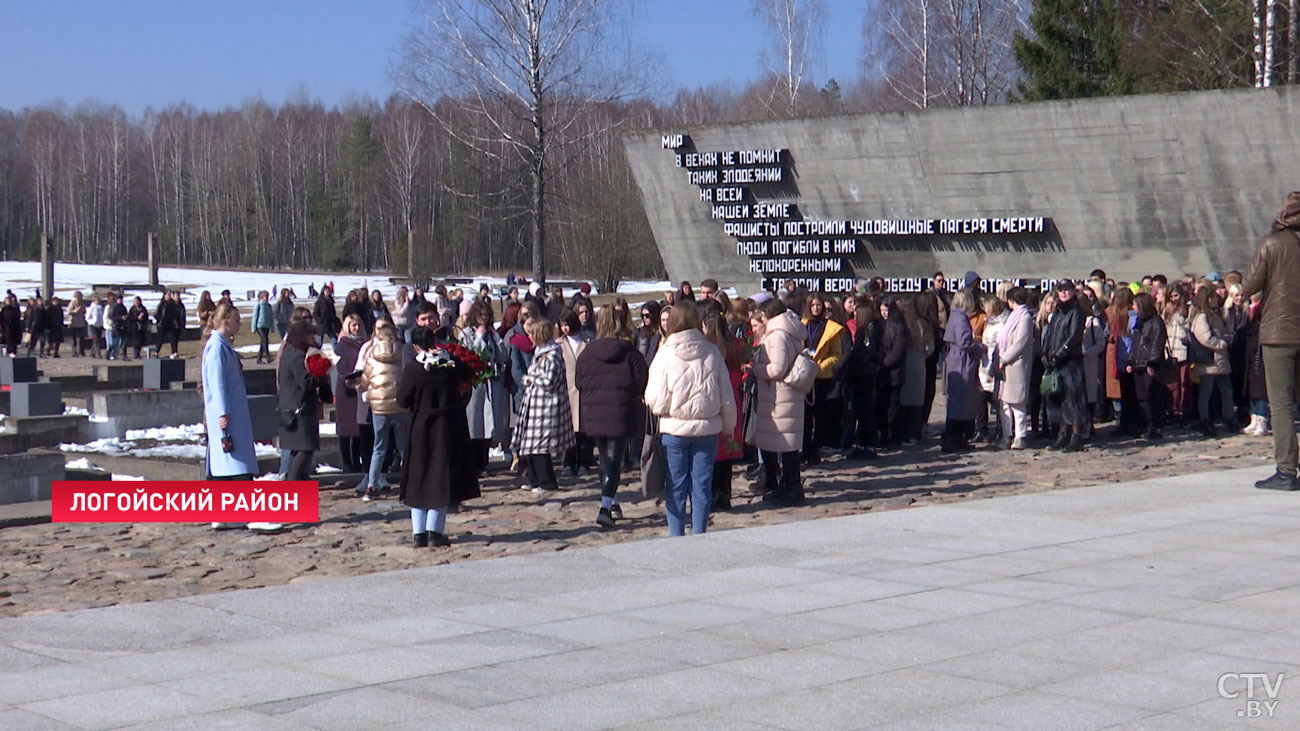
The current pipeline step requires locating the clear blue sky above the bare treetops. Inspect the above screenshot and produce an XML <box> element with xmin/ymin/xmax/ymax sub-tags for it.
<box><xmin>0</xmin><ymin>0</ymin><xmax>866</xmax><ymax>114</ymax></box>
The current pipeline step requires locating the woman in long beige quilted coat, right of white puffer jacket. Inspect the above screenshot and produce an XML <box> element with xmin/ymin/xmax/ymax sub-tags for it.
<box><xmin>746</xmin><ymin>299</ymin><xmax>807</xmax><ymax>507</ymax></box>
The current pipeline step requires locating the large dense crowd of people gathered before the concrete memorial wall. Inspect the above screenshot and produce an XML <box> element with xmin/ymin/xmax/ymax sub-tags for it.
<box><xmin>189</xmin><ymin>193</ymin><xmax>1300</xmax><ymax>546</ymax></box>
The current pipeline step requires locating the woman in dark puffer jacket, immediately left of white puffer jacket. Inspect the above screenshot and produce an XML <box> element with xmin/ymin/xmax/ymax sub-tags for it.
<box><xmin>573</xmin><ymin>307</ymin><xmax>650</xmax><ymax>528</ymax></box>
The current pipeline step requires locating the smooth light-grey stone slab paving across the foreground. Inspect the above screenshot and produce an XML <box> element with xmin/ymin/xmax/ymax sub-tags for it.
<box><xmin>0</xmin><ymin>458</ymin><xmax>1300</xmax><ymax>728</ymax></box>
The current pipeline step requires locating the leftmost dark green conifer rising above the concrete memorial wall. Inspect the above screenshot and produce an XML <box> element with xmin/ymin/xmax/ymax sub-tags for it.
<box><xmin>1013</xmin><ymin>0</ymin><xmax>1132</xmax><ymax>101</ymax></box>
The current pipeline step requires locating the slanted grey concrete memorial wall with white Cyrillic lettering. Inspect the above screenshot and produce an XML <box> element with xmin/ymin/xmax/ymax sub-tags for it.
<box><xmin>624</xmin><ymin>87</ymin><xmax>1300</xmax><ymax>294</ymax></box>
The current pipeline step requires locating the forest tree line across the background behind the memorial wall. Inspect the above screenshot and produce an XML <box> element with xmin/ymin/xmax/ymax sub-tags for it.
<box><xmin>0</xmin><ymin>0</ymin><xmax>1300</xmax><ymax>286</ymax></box>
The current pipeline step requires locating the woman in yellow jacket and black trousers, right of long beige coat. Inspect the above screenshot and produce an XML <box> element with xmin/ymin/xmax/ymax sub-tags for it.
<box><xmin>803</xmin><ymin>294</ymin><xmax>848</xmax><ymax>464</ymax></box>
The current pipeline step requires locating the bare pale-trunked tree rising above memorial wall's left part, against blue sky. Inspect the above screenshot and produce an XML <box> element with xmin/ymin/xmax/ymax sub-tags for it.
<box><xmin>753</xmin><ymin>0</ymin><xmax>827</xmax><ymax>118</ymax></box>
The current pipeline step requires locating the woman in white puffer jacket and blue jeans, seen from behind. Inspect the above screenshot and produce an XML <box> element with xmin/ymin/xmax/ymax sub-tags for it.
<box><xmin>646</xmin><ymin>302</ymin><xmax>736</xmax><ymax>536</ymax></box>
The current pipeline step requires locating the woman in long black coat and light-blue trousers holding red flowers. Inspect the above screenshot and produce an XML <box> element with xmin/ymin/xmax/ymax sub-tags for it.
<box><xmin>398</xmin><ymin>328</ymin><xmax>480</xmax><ymax>548</ymax></box>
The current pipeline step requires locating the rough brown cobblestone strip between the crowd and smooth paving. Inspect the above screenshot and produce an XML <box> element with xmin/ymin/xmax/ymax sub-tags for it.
<box><xmin>0</xmin><ymin>413</ymin><xmax>1271</xmax><ymax>617</ymax></box>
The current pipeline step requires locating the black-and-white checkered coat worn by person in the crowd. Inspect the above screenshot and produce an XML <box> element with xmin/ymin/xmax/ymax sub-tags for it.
<box><xmin>515</xmin><ymin>343</ymin><xmax>577</xmax><ymax>457</ymax></box>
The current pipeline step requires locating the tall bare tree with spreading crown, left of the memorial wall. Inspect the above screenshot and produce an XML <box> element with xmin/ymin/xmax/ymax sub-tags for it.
<box><xmin>395</xmin><ymin>0</ymin><xmax>637</xmax><ymax>282</ymax></box>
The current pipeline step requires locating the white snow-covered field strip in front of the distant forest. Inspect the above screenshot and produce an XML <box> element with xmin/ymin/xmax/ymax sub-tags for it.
<box><xmin>0</xmin><ymin>260</ymin><xmax>672</xmax><ymax>321</ymax></box>
